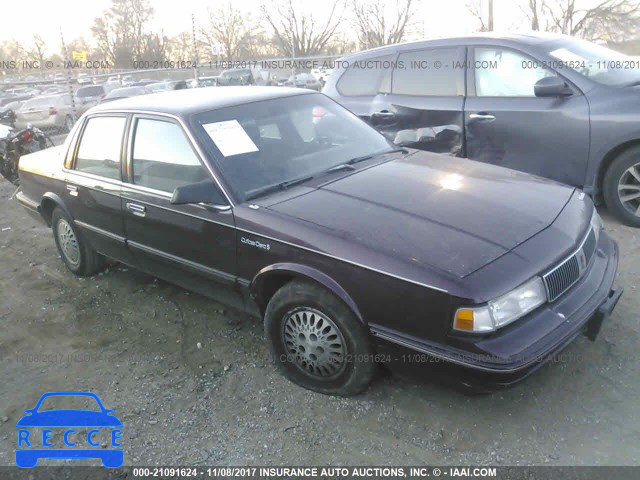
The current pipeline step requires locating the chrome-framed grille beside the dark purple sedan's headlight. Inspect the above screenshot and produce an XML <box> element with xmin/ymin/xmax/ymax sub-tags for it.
<box><xmin>542</xmin><ymin>228</ymin><xmax>597</xmax><ymax>302</ymax></box>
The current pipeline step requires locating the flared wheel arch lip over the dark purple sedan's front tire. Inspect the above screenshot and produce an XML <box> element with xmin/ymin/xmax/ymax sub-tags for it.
<box><xmin>249</xmin><ymin>263</ymin><xmax>366</xmax><ymax>325</ymax></box>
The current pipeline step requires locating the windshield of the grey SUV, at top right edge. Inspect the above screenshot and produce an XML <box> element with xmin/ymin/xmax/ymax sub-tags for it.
<box><xmin>547</xmin><ymin>39</ymin><xmax>640</xmax><ymax>87</ymax></box>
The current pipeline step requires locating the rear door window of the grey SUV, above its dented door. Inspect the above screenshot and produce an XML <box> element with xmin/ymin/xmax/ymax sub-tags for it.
<box><xmin>391</xmin><ymin>47</ymin><xmax>464</xmax><ymax>97</ymax></box>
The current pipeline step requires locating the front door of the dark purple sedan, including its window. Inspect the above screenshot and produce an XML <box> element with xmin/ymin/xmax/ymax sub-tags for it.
<box><xmin>122</xmin><ymin>115</ymin><xmax>237</xmax><ymax>301</ymax></box>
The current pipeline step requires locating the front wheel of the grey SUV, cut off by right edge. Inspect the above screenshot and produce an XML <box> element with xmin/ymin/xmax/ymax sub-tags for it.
<box><xmin>603</xmin><ymin>146</ymin><xmax>640</xmax><ymax>227</ymax></box>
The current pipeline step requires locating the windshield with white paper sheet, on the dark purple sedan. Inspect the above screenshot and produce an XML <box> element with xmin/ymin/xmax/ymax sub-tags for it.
<box><xmin>193</xmin><ymin>94</ymin><xmax>393</xmax><ymax>201</ymax></box>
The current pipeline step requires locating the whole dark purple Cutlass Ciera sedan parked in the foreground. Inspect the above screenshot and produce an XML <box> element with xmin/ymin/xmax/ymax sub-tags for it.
<box><xmin>17</xmin><ymin>87</ymin><xmax>622</xmax><ymax>395</ymax></box>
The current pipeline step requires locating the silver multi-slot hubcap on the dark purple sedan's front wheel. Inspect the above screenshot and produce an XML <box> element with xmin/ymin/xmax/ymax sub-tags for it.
<box><xmin>282</xmin><ymin>307</ymin><xmax>346</xmax><ymax>378</ymax></box>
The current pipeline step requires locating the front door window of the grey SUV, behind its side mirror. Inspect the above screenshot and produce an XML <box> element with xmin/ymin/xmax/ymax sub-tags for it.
<box><xmin>474</xmin><ymin>47</ymin><xmax>555</xmax><ymax>97</ymax></box>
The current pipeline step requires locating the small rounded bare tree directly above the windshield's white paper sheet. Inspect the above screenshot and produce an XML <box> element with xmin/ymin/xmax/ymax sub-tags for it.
<box><xmin>200</xmin><ymin>2</ymin><xmax>258</xmax><ymax>58</ymax></box>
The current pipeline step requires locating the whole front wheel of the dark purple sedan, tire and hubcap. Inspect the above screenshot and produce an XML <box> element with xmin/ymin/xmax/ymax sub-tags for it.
<box><xmin>264</xmin><ymin>280</ymin><xmax>376</xmax><ymax>397</ymax></box>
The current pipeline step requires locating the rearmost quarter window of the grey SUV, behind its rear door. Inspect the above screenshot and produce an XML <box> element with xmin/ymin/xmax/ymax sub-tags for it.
<box><xmin>336</xmin><ymin>55</ymin><xmax>395</xmax><ymax>97</ymax></box>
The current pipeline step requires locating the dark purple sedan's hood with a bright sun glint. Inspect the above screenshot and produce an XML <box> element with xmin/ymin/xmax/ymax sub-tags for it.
<box><xmin>268</xmin><ymin>151</ymin><xmax>574</xmax><ymax>278</ymax></box>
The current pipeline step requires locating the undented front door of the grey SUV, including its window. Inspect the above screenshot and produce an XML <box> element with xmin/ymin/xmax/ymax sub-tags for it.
<box><xmin>465</xmin><ymin>46</ymin><xmax>589</xmax><ymax>187</ymax></box>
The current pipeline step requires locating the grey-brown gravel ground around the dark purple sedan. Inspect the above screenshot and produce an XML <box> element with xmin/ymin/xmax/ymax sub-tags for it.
<box><xmin>0</xmin><ymin>173</ymin><xmax>640</xmax><ymax>465</ymax></box>
